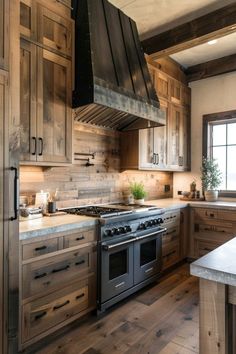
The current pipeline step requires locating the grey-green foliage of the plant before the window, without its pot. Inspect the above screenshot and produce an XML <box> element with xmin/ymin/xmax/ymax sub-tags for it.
<box><xmin>201</xmin><ymin>157</ymin><xmax>222</xmax><ymax>190</ymax></box>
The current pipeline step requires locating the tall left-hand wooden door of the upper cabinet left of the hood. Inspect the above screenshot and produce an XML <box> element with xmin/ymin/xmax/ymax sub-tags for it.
<box><xmin>20</xmin><ymin>39</ymin><xmax>37</xmax><ymax>161</ymax></box>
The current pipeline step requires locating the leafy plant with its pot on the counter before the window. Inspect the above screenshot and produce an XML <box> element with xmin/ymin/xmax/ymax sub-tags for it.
<box><xmin>201</xmin><ymin>157</ymin><xmax>222</xmax><ymax>202</ymax></box>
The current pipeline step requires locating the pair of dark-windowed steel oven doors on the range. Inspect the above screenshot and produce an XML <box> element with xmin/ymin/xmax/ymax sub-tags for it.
<box><xmin>101</xmin><ymin>230</ymin><xmax>163</xmax><ymax>303</ymax></box>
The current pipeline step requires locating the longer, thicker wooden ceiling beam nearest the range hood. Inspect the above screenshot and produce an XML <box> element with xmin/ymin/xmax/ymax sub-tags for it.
<box><xmin>142</xmin><ymin>3</ymin><xmax>236</xmax><ymax>59</ymax></box>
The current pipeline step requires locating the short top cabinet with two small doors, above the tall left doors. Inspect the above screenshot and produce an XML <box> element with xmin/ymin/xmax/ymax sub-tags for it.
<box><xmin>20</xmin><ymin>0</ymin><xmax>72</xmax><ymax>57</ymax></box>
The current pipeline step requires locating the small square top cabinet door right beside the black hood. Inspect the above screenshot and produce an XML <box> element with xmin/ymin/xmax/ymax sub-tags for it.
<box><xmin>37</xmin><ymin>5</ymin><xmax>72</xmax><ymax>56</ymax></box>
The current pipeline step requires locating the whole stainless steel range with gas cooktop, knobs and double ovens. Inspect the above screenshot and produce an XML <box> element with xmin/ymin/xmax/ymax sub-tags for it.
<box><xmin>62</xmin><ymin>204</ymin><xmax>166</xmax><ymax>311</ymax></box>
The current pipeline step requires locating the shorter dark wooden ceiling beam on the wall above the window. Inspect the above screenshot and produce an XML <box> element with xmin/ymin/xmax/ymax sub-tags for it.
<box><xmin>185</xmin><ymin>54</ymin><xmax>236</xmax><ymax>82</ymax></box>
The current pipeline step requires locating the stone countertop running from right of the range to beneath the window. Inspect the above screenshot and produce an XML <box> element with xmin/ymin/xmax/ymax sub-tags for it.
<box><xmin>145</xmin><ymin>198</ymin><xmax>236</xmax><ymax>210</ymax></box>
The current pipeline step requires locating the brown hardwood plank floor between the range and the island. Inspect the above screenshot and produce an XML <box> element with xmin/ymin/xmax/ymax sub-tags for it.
<box><xmin>30</xmin><ymin>265</ymin><xmax>199</xmax><ymax>354</ymax></box>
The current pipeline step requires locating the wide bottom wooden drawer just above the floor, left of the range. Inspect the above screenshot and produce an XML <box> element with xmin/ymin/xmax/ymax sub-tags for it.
<box><xmin>22</xmin><ymin>278</ymin><xmax>92</xmax><ymax>343</ymax></box>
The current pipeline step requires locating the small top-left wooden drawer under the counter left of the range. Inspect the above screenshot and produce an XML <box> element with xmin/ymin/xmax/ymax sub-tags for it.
<box><xmin>22</xmin><ymin>238</ymin><xmax>59</xmax><ymax>260</ymax></box>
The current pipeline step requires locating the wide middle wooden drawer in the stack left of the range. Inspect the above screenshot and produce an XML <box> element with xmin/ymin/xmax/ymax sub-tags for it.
<box><xmin>22</xmin><ymin>246</ymin><xmax>96</xmax><ymax>299</ymax></box>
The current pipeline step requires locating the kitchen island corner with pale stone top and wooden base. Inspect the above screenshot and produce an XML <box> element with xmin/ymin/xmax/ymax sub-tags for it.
<box><xmin>190</xmin><ymin>237</ymin><xmax>236</xmax><ymax>354</ymax></box>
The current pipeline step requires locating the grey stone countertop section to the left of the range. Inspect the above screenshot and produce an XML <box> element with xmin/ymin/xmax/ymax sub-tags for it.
<box><xmin>20</xmin><ymin>214</ymin><xmax>97</xmax><ymax>240</ymax></box>
